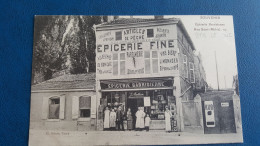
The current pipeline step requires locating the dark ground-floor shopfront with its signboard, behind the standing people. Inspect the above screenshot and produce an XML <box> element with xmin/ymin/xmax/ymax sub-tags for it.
<box><xmin>100</xmin><ymin>77</ymin><xmax>176</xmax><ymax>129</ymax></box>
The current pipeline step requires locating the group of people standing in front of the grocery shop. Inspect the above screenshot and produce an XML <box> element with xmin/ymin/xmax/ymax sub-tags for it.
<box><xmin>104</xmin><ymin>106</ymin><xmax>172</xmax><ymax>132</ymax></box>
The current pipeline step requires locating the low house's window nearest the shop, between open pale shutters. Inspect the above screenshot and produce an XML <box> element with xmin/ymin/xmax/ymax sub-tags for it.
<box><xmin>79</xmin><ymin>96</ymin><xmax>91</xmax><ymax>118</ymax></box>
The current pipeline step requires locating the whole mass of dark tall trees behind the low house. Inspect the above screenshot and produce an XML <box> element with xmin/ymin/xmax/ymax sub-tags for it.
<box><xmin>32</xmin><ymin>16</ymin><xmax>104</xmax><ymax>81</ymax></box>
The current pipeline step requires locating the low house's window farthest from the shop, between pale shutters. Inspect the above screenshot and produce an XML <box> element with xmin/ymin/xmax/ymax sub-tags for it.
<box><xmin>49</xmin><ymin>97</ymin><xmax>60</xmax><ymax>119</ymax></box>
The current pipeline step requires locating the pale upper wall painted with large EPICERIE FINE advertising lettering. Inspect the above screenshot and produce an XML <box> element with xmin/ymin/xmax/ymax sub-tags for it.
<box><xmin>96</xmin><ymin>26</ymin><xmax>178</xmax><ymax>78</ymax></box>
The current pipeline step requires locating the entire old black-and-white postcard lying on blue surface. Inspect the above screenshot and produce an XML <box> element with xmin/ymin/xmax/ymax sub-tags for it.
<box><xmin>29</xmin><ymin>15</ymin><xmax>243</xmax><ymax>146</ymax></box>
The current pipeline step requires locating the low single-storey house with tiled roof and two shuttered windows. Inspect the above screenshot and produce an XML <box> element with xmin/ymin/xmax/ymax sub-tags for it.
<box><xmin>30</xmin><ymin>73</ymin><xmax>96</xmax><ymax>131</ymax></box>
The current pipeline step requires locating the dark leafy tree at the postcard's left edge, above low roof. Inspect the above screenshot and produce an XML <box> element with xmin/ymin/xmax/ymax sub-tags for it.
<box><xmin>32</xmin><ymin>16</ymin><xmax>68</xmax><ymax>81</ymax></box>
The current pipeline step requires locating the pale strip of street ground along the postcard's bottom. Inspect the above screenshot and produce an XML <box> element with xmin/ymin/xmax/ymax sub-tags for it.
<box><xmin>29</xmin><ymin>130</ymin><xmax>243</xmax><ymax>146</ymax></box>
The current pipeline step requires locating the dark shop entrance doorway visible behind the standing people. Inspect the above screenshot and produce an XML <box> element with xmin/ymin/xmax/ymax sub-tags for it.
<box><xmin>127</xmin><ymin>98</ymin><xmax>144</xmax><ymax>129</ymax></box>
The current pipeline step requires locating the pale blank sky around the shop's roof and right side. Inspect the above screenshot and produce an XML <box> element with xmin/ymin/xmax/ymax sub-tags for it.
<box><xmin>121</xmin><ymin>15</ymin><xmax>237</xmax><ymax>89</ymax></box>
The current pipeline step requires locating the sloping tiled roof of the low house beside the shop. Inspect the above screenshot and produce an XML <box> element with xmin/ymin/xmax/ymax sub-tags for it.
<box><xmin>31</xmin><ymin>73</ymin><xmax>96</xmax><ymax>91</ymax></box>
